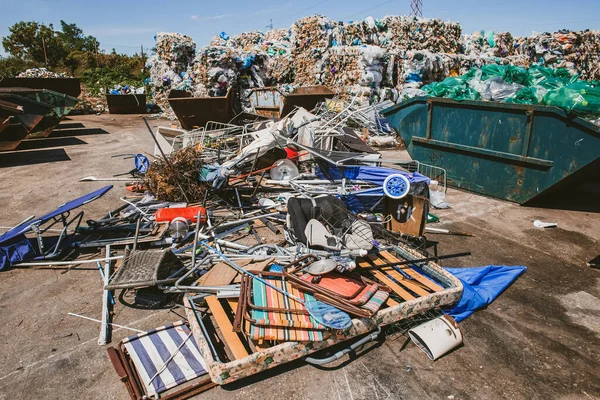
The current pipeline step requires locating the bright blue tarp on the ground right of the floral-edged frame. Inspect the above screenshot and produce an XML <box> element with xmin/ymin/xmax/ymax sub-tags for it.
<box><xmin>444</xmin><ymin>265</ymin><xmax>527</xmax><ymax>322</ymax></box>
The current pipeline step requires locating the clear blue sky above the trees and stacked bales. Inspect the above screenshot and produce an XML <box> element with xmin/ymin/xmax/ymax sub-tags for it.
<box><xmin>0</xmin><ymin>0</ymin><xmax>600</xmax><ymax>54</ymax></box>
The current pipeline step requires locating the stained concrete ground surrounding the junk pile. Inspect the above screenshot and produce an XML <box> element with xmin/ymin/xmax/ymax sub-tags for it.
<box><xmin>0</xmin><ymin>115</ymin><xmax>600</xmax><ymax>400</ymax></box>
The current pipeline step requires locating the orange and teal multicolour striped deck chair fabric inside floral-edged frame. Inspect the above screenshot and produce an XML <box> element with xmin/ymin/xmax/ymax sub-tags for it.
<box><xmin>244</xmin><ymin>274</ymin><xmax>328</xmax><ymax>342</ymax></box>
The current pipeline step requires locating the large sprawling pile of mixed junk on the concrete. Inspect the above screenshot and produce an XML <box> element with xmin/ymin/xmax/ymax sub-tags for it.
<box><xmin>0</xmin><ymin>98</ymin><xmax>525</xmax><ymax>399</ymax></box>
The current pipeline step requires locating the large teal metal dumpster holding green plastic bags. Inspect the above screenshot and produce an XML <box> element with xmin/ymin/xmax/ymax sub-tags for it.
<box><xmin>382</xmin><ymin>97</ymin><xmax>600</xmax><ymax>204</ymax></box>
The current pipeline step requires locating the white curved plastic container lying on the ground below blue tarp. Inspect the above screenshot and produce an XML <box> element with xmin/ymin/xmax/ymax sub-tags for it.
<box><xmin>408</xmin><ymin>315</ymin><xmax>462</xmax><ymax>360</ymax></box>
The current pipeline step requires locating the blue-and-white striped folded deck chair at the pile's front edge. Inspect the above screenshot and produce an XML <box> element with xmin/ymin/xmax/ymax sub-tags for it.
<box><xmin>122</xmin><ymin>321</ymin><xmax>207</xmax><ymax>398</ymax></box>
